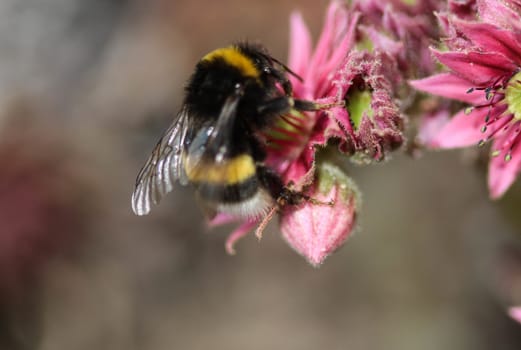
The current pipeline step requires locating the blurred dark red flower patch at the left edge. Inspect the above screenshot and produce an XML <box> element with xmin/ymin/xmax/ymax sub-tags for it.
<box><xmin>0</xmin><ymin>114</ymin><xmax>87</xmax><ymax>295</ymax></box>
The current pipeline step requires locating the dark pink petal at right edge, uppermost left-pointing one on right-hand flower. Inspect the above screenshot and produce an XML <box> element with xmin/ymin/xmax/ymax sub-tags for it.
<box><xmin>452</xmin><ymin>19</ymin><xmax>521</xmax><ymax>62</ymax></box>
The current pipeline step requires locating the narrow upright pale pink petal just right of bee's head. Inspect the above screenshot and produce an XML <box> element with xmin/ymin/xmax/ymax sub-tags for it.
<box><xmin>288</xmin><ymin>12</ymin><xmax>311</xmax><ymax>75</ymax></box>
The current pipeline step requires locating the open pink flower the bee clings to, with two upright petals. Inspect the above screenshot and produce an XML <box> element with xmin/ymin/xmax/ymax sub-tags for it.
<box><xmin>266</xmin><ymin>1</ymin><xmax>359</xmax><ymax>185</ymax></box>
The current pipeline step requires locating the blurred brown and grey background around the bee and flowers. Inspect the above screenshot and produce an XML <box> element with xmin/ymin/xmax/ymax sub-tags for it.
<box><xmin>0</xmin><ymin>0</ymin><xmax>521</xmax><ymax>350</ymax></box>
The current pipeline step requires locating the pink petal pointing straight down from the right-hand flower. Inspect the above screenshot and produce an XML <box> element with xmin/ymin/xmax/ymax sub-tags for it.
<box><xmin>488</xmin><ymin>133</ymin><xmax>521</xmax><ymax>199</ymax></box>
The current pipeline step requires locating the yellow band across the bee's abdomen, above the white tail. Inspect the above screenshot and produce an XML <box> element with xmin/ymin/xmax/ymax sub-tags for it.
<box><xmin>185</xmin><ymin>154</ymin><xmax>256</xmax><ymax>185</ymax></box>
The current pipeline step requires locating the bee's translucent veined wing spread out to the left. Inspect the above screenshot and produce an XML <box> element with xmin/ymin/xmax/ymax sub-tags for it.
<box><xmin>132</xmin><ymin>108</ymin><xmax>189</xmax><ymax>215</ymax></box>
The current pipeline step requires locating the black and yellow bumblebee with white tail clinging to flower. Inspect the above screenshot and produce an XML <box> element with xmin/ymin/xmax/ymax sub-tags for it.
<box><xmin>132</xmin><ymin>43</ymin><xmax>320</xmax><ymax>218</ymax></box>
